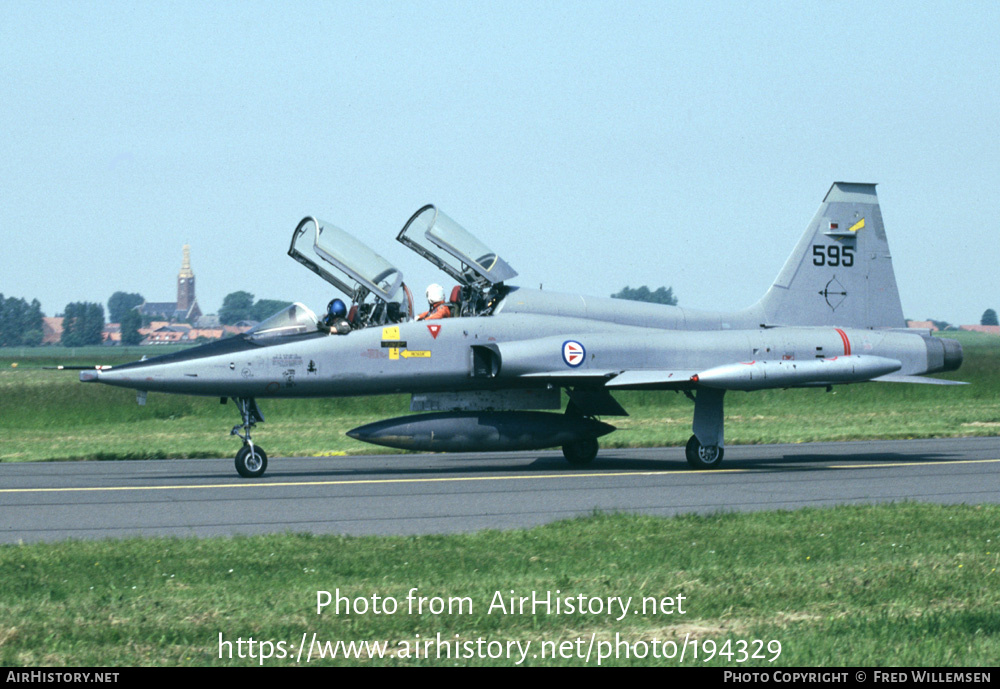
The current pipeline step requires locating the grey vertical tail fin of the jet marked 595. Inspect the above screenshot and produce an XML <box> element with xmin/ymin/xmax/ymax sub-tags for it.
<box><xmin>757</xmin><ymin>182</ymin><xmax>906</xmax><ymax>328</ymax></box>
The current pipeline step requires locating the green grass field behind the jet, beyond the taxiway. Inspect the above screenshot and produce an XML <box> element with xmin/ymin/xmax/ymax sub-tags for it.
<box><xmin>0</xmin><ymin>333</ymin><xmax>1000</xmax><ymax>462</ymax></box>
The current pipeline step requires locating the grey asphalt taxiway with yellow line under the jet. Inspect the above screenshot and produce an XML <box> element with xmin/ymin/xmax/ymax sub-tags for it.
<box><xmin>0</xmin><ymin>438</ymin><xmax>1000</xmax><ymax>543</ymax></box>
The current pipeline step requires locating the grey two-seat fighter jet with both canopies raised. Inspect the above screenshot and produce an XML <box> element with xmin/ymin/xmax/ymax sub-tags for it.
<box><xmin>80</xmin><ymin>182</ymin><xmax>962</xmax><ymax>478</ymax></box>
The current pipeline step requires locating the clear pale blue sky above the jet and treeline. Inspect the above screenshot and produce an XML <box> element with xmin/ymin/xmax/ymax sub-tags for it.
<box><xmin>0</xmin><ymin>0</ymin><xmax>1000</xmax><ymax>323</ymax></box>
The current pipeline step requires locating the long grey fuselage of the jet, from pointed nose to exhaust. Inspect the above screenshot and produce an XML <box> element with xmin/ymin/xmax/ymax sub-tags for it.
<box><xmin>81</xmin><ymin>295</ymin><xmax>960</xmax><ymax>398</ymax></box>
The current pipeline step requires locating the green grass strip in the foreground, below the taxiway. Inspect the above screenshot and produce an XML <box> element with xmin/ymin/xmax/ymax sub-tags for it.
<box><xmin>0</xmin><ymin>504</ymin><xmax>1000</xmax><ymax>667</ymax></box>
